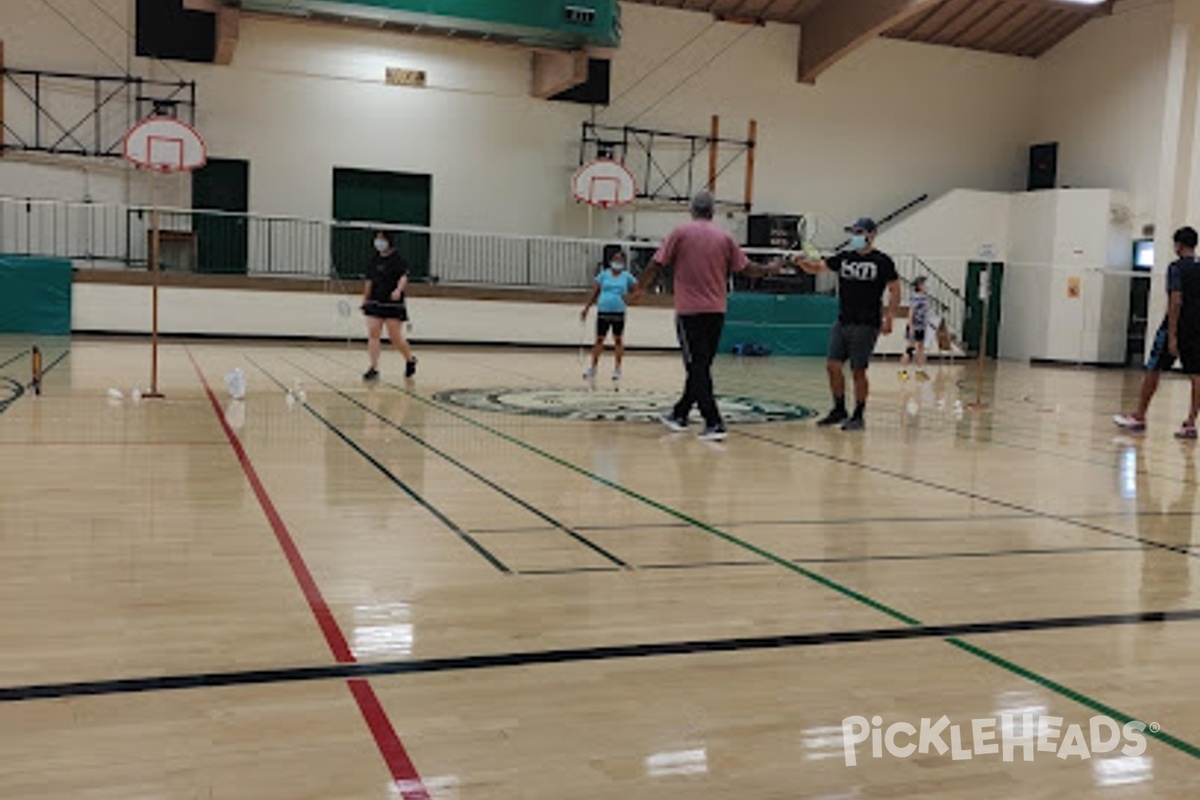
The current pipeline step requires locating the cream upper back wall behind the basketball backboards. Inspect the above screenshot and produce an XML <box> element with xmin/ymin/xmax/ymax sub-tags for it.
<box><xmin>0</xmin><ymin>0</ymin><xmax>1037</xmax><ymax>237</ymax></box>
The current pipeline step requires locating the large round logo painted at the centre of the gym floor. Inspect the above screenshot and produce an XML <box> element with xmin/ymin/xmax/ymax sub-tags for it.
<box><xmin>436</xmin><ymin>387</ymin><xmax>816</xmax><ymax>425</ymax></box>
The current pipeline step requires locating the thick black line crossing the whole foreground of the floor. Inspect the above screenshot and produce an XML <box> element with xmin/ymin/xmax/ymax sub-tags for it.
<box><xmin>7</xmin><ymin>609</ymin><xmax>1200</xmax><ymax>703</ymax></box>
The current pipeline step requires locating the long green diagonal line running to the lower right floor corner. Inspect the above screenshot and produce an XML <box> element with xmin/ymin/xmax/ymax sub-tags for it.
<box><xmin>307</xmin><ymin>353</ymin><xmax>1200</xmax><ymax>759</ymax></box>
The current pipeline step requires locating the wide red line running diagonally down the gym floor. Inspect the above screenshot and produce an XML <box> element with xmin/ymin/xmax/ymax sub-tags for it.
<box><xmin>187</xmin><ymin>351</ymin><xmax>432</xmax><ymax>800</ymax></box>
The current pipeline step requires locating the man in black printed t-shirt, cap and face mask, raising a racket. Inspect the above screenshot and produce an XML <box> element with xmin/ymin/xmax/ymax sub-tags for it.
<box><xmin>797</xmin><ymin>218</ymin><xmax>900</xmax><ymax>431</ymax></box>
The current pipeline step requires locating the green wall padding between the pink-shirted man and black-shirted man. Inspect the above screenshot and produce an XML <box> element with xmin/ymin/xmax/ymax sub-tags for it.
<box><xmin>721</xmin><ymin>294</ymin><xmax>838</xmax><ymax>356</ymax></box>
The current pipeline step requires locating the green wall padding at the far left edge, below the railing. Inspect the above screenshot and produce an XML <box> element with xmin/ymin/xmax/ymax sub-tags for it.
<box><xmin>0</xmin><ymin>255</ymin><xmax>71</xmax><ymax>336</ymax></box>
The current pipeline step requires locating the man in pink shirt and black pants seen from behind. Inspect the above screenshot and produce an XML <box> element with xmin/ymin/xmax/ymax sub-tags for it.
<box><xmin>632</xmin><ymin>192</ymin><xmax>780</xmax><ymax>441</ymax></box>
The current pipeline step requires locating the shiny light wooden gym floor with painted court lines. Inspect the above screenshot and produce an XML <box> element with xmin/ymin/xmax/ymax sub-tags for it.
<box><xmin>0</xmin><ymin>339</ymin><xmax>1200</xmax><ymax>800</ymax></box>
